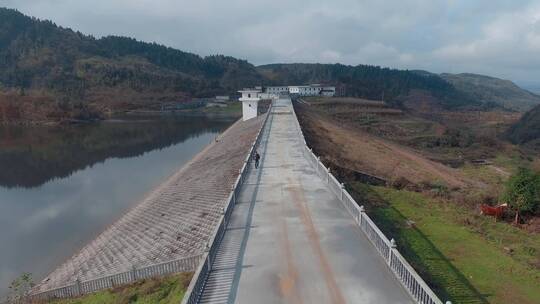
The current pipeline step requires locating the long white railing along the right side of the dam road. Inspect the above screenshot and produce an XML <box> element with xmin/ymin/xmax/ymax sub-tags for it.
<box><xmin>293</xmin><ymin>100</ymin><xmax>451</xmax><ymax>304</ymax></box>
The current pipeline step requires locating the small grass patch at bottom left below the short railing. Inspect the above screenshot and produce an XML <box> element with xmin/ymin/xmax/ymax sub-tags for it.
<box><xmin>49</xmin><ymin>273</ymin><xmax>192</xmax><ymax>304</ymax></box>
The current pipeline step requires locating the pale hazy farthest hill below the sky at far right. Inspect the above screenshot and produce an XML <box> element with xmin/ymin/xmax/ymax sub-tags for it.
<box><xmin>441</xmin><ymin>73</ymin><xmax>540</xmax><ymax>111</ymax></box>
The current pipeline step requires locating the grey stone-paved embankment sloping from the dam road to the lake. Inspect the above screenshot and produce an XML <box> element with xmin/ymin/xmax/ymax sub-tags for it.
<box><xmin>35</xmin><ymin>117</ymin><xmax>264</xmax><ymax>292</ymax></box>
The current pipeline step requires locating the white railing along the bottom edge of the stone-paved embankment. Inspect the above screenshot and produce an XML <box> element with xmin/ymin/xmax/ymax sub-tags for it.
<box><xmin>30</xmin><ymin>254</ymin><xmax>202</xmax><ymax>301</ymax></box>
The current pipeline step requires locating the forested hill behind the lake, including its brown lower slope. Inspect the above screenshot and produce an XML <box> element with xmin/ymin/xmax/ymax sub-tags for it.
<box><xmin>0</xmin><ymin>8</ymin><xmax>262</xmax><ymax>121</ymax></box>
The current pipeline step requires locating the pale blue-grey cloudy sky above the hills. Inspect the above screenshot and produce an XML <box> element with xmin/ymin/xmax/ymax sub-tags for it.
<box><xmin>0</xmin><ymin>0</ymin><xmax>540</xmax><ymax>86</ymax></box>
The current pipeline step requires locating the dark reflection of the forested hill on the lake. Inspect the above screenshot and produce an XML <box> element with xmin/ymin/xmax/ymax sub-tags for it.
<box><xmin>0</xmin><ymin>117</ymin><xmax>230</xmax><ymax>187</ymax></box>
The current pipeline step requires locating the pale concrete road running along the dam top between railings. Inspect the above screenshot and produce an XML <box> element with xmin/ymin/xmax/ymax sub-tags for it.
<box><xmin>201</xmin><ymin>99</ymin><xmax>413</xmax><ymax>304</ymax></box>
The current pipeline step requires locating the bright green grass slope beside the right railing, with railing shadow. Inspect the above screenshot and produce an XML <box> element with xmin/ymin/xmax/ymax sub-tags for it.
<box><xmin>352</xmin><ymin>184</ymin><xmax>540</xmax><ymax>303</ymax></box>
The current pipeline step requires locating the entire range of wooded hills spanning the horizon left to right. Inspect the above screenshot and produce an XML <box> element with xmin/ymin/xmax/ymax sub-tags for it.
<box><xmin>0</xmin><ymin>8</ymin><xmax>536</xmax><ymax>123</ymax></box>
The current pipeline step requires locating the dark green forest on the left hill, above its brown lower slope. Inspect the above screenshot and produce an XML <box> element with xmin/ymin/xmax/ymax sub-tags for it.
<box><xmin>0</xmin><ymin>8</ymin><xmax>261</xmax><ymax>94</ymax></box>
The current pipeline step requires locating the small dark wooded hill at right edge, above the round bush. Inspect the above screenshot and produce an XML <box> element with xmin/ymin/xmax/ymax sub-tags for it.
<box><xmin>508</xmin><ymin>105</ymin><xmax>540</xmax><ymax>150</ymax></box>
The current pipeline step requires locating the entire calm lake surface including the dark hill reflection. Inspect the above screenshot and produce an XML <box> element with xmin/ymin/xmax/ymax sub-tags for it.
<box><xmin>0</xmin><ymin>117</ymin><xmax>233</xmax><ymax>298</ymax></box>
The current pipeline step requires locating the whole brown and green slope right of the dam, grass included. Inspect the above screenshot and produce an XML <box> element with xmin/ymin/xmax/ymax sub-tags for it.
<box><xmin>295</xmin><ymin>98</ymin><xmax>540</xmax><ymax>304</ymax></box>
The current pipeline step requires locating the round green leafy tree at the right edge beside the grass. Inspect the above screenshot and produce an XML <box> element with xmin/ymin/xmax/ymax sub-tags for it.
<box><xmin>502</xmin><ymin>168</ymin><xmax>540</xmax><ymax>224</ymax></box>
